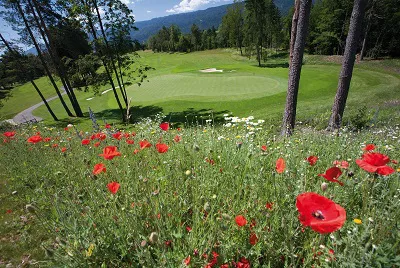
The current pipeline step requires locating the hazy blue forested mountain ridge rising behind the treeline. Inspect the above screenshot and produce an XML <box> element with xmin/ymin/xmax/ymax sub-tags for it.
<box><xmin>131</xmin><ymin>0</ymin><xmax>294</xmax><ymax>43</ymax></box>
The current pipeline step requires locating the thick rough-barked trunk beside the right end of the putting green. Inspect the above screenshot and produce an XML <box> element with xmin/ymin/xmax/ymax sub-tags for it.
<box><xmin>281</xmin><ymin>0</ymin><xmax>312</xmax><ymax>136</ymax></box>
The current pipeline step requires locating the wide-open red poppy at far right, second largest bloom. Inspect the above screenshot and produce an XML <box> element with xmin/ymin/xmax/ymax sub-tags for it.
<box><xmin>356</xmin><ymin>153</ymin><xmax>394</xmax><ymax>175</ymax></box>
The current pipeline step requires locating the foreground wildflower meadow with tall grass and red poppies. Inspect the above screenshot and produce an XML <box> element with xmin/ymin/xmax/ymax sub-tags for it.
<box><xmin>0</xmin><ymin>114</ymin><xmax>400</xmax><ymax>267</ymax></box>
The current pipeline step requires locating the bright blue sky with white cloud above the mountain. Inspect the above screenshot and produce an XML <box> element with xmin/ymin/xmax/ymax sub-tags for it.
<box><xmin>0</xmin><ymin>0</ymin><xmax>233</xmax><ymax>46</ymax></box>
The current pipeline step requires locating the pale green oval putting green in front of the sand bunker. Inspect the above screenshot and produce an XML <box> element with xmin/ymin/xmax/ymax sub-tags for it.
<box><xmin>128</xmin><ymin>73</ymin><xmax>286</xmax><ymax>103</ymax></box>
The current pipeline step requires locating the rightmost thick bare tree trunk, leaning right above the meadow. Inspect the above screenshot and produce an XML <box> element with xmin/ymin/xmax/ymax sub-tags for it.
<box><xmin>327</xmin><ymin>0</ymin><xmax>368</xmax><ymax>131</ymax></box>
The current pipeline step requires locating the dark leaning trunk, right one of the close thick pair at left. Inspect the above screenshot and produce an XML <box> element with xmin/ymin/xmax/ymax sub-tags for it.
<box><xmin>28</xmin><ymin>0</ymin><xmax>83</xmax><ymax>117</ymax></box>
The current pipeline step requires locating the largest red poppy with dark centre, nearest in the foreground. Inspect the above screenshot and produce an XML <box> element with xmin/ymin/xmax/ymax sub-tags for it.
<box><xmin>296</xmin><ymin>192</ymin><xmax>346</xmax><ymax>234</ymax></box>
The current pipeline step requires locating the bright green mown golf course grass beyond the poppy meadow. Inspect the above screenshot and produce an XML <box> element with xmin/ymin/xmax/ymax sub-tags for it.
<box><xmin>3</xmin><ymin>50</ymin><xmax>400</xmax><ymax>129</ymax></box>
